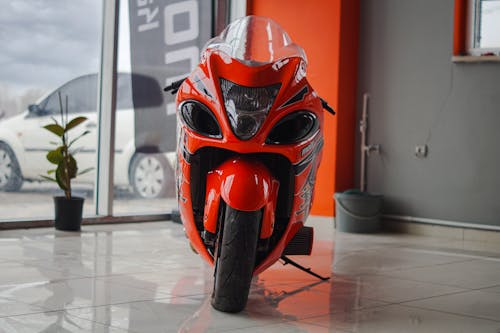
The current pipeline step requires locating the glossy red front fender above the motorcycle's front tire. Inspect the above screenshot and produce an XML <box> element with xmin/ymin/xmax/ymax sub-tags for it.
<box><xmin>203</xmin><ymin>157</ymin><xmax>279</xmax><ymax>238</ymax></box>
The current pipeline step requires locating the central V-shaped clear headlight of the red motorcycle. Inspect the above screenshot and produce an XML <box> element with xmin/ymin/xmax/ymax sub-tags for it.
<box><xmin>220</xmin><ymin>78</ymin><xmax>281</xmax><ymax>140</ymax></box>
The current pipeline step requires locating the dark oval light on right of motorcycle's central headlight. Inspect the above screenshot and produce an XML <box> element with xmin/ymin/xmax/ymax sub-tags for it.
<box><xmin>266</xmin><ymin>111</ymin><xmax>319</xmax><ymax>144</ymax></box>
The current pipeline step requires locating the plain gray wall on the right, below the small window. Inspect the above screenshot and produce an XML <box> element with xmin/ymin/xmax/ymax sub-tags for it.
<box><xmin>357</xmin><ymin>0</ymin><xmax>500</xmax><ymax>225</ymax></box>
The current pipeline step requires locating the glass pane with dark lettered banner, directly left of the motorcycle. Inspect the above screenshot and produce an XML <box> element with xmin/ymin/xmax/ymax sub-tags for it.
<box><xmin>113</xmin><ymin>0</ymin><xmax>212</xmax><ymax>215</ymax></box>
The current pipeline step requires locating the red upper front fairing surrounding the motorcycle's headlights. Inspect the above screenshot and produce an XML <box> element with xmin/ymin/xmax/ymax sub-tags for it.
<box><xmin>177</xmin><ymin>51</ymin><xmax>323</xmax><ymax>158</ymax></box>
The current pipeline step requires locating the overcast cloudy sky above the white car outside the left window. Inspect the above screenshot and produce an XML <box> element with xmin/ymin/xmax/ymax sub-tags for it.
<box><xmin>0</xmin><ymin>0</ymin><xmax>102</xmax><ymax>93</ymax></box>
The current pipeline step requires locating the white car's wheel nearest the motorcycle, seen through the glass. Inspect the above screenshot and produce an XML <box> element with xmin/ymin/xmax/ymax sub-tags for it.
<box><xmin>130</xmin><ymin>153</ymin><xmax>175</xmax><ymax>199</ymax></box>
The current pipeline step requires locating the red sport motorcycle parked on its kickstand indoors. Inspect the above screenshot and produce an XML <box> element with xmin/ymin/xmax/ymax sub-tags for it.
<box><xmin>165</xmin><ymin>16</ymin><xmax>334</xmax><ymax>312</ymax></box>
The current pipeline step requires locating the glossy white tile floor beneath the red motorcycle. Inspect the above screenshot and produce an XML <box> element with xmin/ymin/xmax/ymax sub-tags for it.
<box><xmin>0</xmin><ymin>217</ymin><xmax>500</xmax><ymax>333</ymax></box>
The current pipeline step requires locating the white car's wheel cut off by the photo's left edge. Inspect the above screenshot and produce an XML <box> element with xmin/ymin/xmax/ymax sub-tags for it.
<box><xmin>0</xmin><ymin>142</ymin><xmax>23</xmax><ymax>192</ymax></box>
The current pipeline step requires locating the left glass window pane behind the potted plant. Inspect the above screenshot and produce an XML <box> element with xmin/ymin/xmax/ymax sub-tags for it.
<box><xmin>0</xmin><ymin>0</ymin><xmax>103</xmax><ymax>221</ymax></box>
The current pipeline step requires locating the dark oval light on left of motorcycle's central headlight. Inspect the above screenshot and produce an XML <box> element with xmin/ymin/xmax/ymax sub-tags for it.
<box><xmin>180</xmin><ymin>101</ymin><xmax>222</xmax><ymax>138</ymax></box>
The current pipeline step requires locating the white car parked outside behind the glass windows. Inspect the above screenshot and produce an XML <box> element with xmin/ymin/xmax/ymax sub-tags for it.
<box><xmin>0</xmin><ymin>74</ymin><xmax>175</xmax><ymax>198</ymax></box>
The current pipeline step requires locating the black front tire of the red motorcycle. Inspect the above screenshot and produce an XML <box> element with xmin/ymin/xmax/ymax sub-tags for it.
<box><xmin>212</xmin><ymin>206</ymin><xmax>262</xmax><ymax>313</ymax></box>
